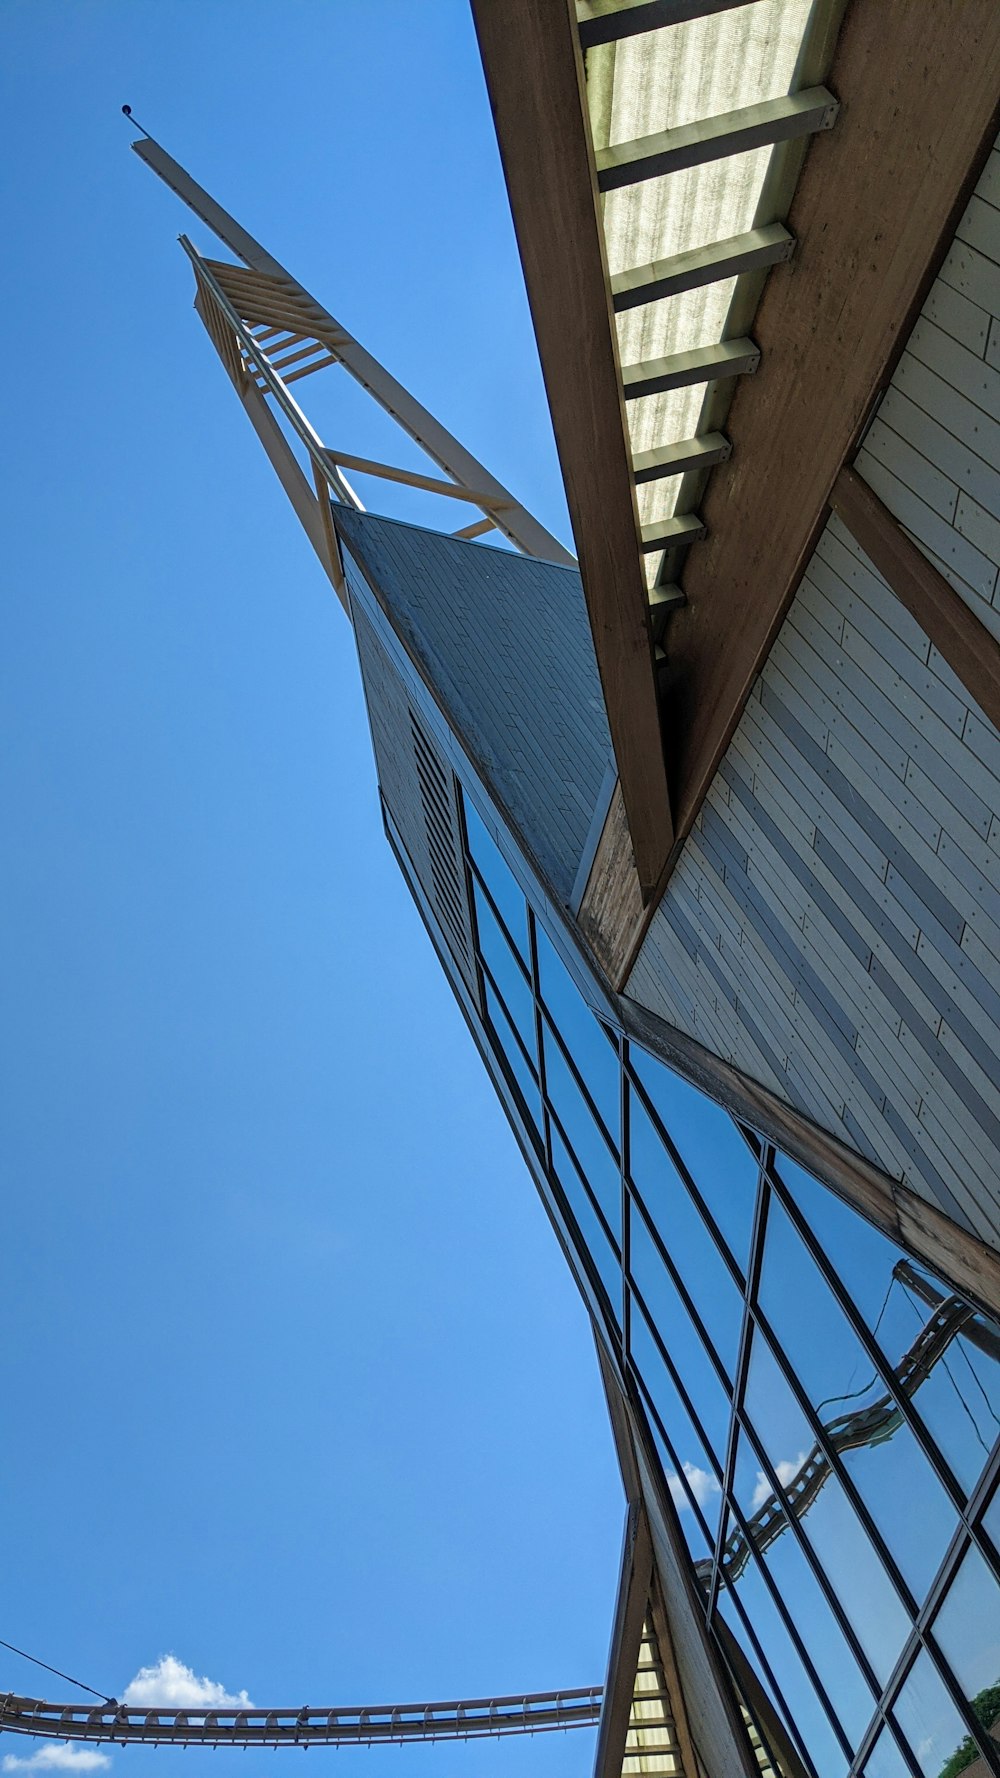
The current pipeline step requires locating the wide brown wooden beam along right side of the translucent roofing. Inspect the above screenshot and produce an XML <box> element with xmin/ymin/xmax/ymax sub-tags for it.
<box><xmin>654</xmin><ymin>0</ymin><xmax>1000</xmax><ymax>867</ymax></box>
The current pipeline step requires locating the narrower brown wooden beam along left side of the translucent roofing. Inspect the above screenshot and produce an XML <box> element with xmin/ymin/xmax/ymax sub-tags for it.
<box><xmin>472</xmin><ymin>0</ymin><xmax>673</xmax><ymax>893</ymax></box>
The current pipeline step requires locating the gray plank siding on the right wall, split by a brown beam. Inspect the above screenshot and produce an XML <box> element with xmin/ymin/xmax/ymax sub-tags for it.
<box><xmin>628</xmin><ymin>151</ymin><xmax>1000</xmax><ymax>1246</ymax></box>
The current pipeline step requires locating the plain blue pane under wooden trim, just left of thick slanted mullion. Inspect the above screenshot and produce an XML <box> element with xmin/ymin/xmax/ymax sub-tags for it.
<box><xmin>630</xmin><ymin>1044</ymin><xmax>758</xmax><ymax>1271</ymax></box>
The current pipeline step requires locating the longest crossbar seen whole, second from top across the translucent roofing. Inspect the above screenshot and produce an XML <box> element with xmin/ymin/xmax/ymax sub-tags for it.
<box><xmin>596</xmin><ymin>87</ymin><xmax>840</xmax><ymax>192</ymax></box>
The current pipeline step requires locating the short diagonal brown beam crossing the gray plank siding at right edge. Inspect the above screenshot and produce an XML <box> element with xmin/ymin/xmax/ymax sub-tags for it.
<box><xmin>831</xmin><ymin>469</ymin><xmax>1000</xmax><ymax>729</ymax></box>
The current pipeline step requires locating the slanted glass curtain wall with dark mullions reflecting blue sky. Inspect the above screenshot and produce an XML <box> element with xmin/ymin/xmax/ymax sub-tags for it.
<box><xmin>464</xmin><ymin>800</ymin><xmax>1000</xmax><ymax>1778</ymax></box>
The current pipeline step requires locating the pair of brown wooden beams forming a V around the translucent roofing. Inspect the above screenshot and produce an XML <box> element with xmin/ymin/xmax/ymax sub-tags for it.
<box><xmin>473</xmin><ymin>0</ymin><xmax>1000</xmax><ymax>987</ymax></box>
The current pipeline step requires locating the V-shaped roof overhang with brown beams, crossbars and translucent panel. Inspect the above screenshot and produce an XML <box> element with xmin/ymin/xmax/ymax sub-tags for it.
<box><xmin>472</xmin><ymin>0</ymin><xmax>1000</xmax><ymax>987</ymax></box>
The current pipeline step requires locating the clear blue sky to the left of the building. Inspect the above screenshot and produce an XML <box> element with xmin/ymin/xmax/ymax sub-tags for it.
<box><xmin>0</xmin><ymin>0</ymin><xmax>623</xmax><ymax>1778</ymax></box>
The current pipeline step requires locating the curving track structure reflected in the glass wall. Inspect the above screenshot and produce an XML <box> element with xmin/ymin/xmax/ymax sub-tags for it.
<box><xmin>696</xmin><ymin>1259</ymin><xmax>1000</xmax><ymax>1584</ymax></box>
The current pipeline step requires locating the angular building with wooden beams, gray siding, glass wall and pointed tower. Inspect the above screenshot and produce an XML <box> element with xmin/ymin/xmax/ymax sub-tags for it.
<box><xmin>137</xmin><ymin>0</ymin><xmax>1000</xmax><ymax>1778</ymax></box>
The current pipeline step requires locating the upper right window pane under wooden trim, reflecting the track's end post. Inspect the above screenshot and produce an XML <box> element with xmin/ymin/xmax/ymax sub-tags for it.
<box><xmin>779</xmin><ymin>1159</ymin><xmax>1000</xmax><ymax>1494</ymax></box>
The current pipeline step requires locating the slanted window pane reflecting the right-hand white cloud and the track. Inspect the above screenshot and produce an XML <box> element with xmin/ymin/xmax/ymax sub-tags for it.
<box><xmin>735</xmin><ymin>1328</ymin><xmax>909</xmax><ymax>1682</ymax></box>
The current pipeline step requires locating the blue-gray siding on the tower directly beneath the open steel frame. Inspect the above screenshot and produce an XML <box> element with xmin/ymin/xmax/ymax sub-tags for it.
<box><xmin>338</xmin><ymin>509</ymin><xmax>614</xmax><ymax>903</ymax></box>
